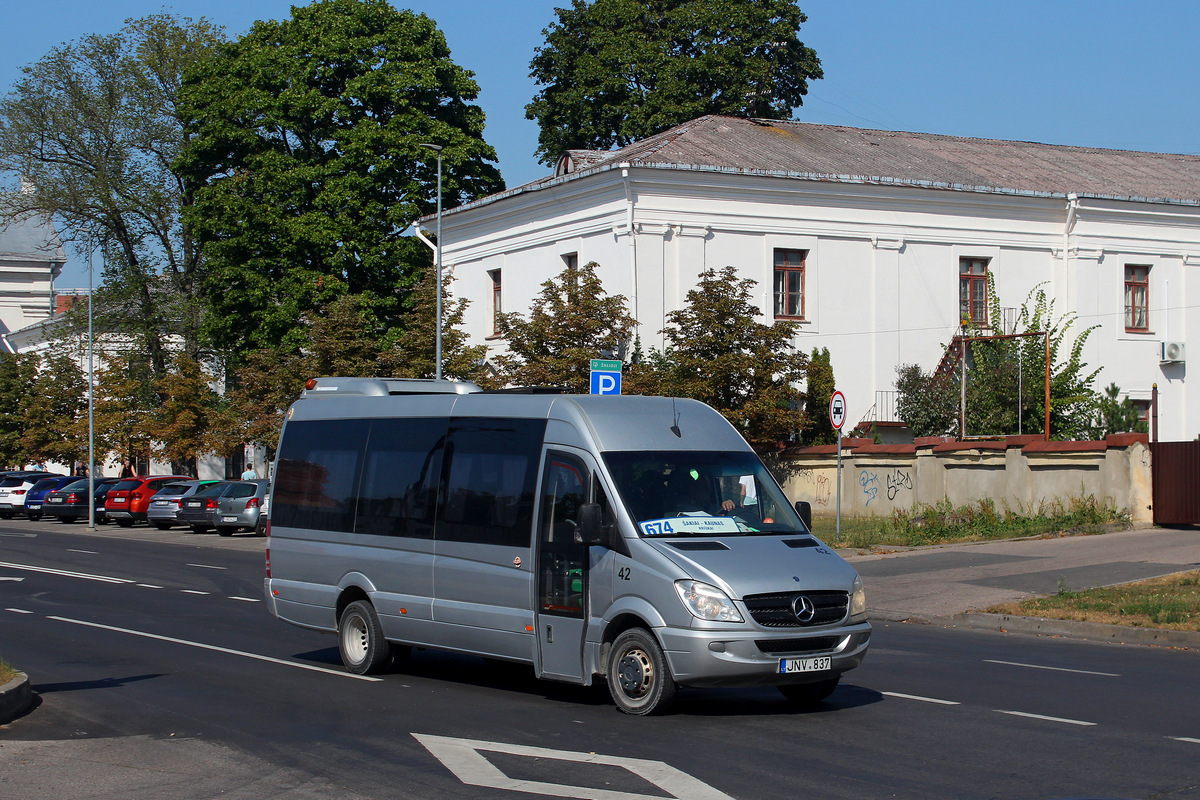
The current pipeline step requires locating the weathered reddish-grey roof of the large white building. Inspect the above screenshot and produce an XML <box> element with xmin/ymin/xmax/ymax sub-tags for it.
<box><xmin>430</xmin><ymin>115</ymin><xmax>1200</xmax><ymax>218</ymax></box>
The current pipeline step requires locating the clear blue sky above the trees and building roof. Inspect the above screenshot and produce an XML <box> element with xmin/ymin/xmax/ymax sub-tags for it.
<box><xmin>0</xmin><ymin>0</ymin><xmax>1200</xmax><ymax>287</ymax></box>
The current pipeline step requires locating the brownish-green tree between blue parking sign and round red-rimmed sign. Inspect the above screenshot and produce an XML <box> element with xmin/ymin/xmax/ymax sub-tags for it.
<box><xmin>638</xmin><ymin>266</ymin><xmax>809</xmax><ymax>451</ymax></box>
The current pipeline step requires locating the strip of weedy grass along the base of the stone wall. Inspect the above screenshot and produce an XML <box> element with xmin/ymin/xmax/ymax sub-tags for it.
<box><xmin>812</xmin><ymin>497</ymin><xmax>1129</xmax><ymax>548</ymax></box>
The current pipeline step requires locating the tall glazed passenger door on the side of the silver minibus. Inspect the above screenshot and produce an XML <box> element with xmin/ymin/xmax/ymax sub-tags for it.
<box><xmin>535</xmin><ymin>450</ymin><xmax>593</xmax><ymax>681</ymax></box>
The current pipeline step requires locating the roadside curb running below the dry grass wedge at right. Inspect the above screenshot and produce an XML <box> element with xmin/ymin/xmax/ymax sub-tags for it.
<box><xmin>870</xmin><ymin>610</ymin><xmax>1200</xmax><ymax>650</ymax></box>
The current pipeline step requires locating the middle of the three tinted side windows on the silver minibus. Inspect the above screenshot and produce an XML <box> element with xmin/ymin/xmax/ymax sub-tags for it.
<box><xmin>354</xmin><ymin>419</ymin><xmax>449</xmax><ymax>539</ymax></box>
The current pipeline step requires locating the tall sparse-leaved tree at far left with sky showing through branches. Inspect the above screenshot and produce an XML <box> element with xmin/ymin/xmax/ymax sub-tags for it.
<box><xmin>0</xmin><ymin>14</ymin><xmax>222</xmax><ymax>374</ymax></box>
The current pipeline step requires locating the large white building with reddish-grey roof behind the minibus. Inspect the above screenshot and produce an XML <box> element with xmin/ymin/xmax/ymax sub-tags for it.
<box><xmin>432</xmin><ymin>116</ymin><xmax>1200</xmax><ymax>440</ymax></box>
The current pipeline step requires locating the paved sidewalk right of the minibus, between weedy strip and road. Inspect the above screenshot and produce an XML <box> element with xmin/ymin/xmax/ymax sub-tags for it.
<box><xmin>839</xmin><ymin>528</ymin><xmax>1200</xmax><ymax>648</ymax></box>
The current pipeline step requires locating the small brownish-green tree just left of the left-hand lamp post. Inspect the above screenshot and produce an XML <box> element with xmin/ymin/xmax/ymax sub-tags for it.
<box><xmin>22</xmin><ymin>355</ymin><xmax>88</xmax><ymax>467</ymax></box>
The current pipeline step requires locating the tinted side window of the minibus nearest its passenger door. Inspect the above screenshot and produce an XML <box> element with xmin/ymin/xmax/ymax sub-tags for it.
<box><xmin>438</xmin><ymin>419</ymin><xmax>546</xmax><ymax>547</ymax></box>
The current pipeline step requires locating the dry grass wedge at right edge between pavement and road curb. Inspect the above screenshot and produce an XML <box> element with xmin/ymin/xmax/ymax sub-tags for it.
<box><xmin>988</xmin><ymin>570</ymin><xmax>1200</xmax><ymax>631</ymax></box>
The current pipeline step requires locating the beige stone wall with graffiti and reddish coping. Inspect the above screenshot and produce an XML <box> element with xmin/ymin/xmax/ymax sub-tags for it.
<box><xmin>782</xmin><ymin>433</ymin><xmax>1153</xmax><ymax>522</ymax></box>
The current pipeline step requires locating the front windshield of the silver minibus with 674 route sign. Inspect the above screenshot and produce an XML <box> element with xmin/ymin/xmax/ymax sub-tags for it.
<box><xmin>604</xmin><ymin>450</ymin><xmax>809</xmax><ymax>536</ymax></box>
